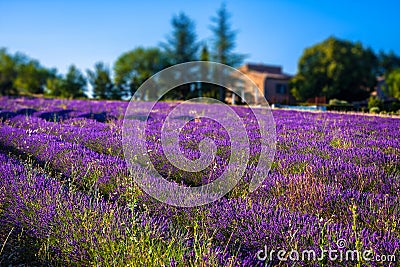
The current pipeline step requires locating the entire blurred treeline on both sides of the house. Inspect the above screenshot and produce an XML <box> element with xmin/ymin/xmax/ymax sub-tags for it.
<box><xmin>0</xmin><ymin>5</ymin><xmax>400</xmax><ymax>102</ymax></box>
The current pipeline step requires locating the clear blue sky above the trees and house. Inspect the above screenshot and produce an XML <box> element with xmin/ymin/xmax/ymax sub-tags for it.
<box><xmin>0</xmin><ymin>0</ymin><xmax>400</xmax><ymax>74</ymax></box>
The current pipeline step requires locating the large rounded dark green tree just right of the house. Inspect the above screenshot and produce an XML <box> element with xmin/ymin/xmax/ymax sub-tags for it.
<box><xmin>291</xmin><ymin>37</ymin><xmax>378</xmax><ymax>101</ymax></box>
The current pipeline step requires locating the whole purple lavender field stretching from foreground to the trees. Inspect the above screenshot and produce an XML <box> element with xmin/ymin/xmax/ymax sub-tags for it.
<box><xmin>0</xmin><ymin>97</ymin><xmax>400</xmax><ymax>266</ymax></box>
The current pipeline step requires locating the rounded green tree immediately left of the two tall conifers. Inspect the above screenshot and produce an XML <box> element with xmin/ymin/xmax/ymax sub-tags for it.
<box><xmin>114</xmin><ymin>47</ymin><xmax>169</xmax><ymax>99</ymax></box>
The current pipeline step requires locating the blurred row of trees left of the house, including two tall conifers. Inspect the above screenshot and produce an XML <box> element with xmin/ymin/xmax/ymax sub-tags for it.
<box><xmin>0</xmin><ymin>4</ymin><xmax>245</xmax><ymax>99</ymax></box>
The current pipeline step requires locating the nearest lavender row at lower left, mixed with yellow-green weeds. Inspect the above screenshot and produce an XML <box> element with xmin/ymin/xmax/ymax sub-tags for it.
<box><xmin>0</xmin><ymin>154</ymin><xmax>244</xmax><ymax>266</ymax></box>
